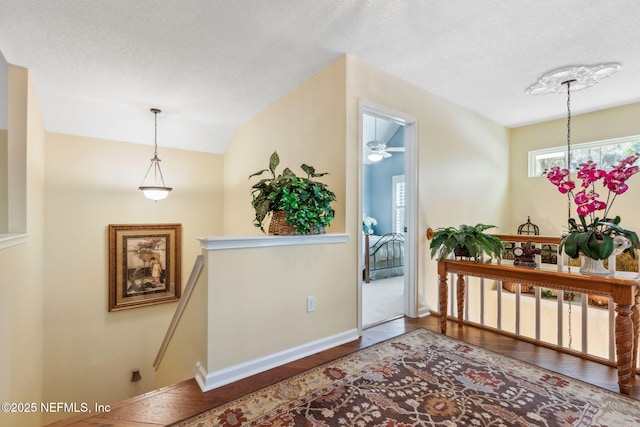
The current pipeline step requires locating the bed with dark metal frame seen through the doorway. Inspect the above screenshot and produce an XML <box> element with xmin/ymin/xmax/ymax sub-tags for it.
<box><xmin>364</xmin><ymin>233</ymin><xmax>404</xmax><ymax>283</ymax></box>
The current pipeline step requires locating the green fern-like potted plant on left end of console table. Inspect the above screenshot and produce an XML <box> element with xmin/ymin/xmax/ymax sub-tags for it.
<box><xmin>429</xmin><ymin>224</ymin><xmax>504</xmax><ymax>262</ymax></box>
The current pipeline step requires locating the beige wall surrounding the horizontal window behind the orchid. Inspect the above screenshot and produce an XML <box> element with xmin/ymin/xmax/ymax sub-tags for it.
<box><xmin>507</xmin><ymin>104</ymin><xmax>640</xmax><ymax>236</ymax></box>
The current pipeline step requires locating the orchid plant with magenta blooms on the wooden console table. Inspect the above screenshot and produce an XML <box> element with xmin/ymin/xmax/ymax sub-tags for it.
<box><xmin>546</xmin><ymin>153</ymin><xmax>640</xmax><ymax>259</ymax></box>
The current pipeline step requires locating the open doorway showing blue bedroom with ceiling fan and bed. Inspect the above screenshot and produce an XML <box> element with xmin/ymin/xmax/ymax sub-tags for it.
<box><xmin>359</xmin><ymin>104</ymin><xmax>417</xmax><ymax>328</ymax></box>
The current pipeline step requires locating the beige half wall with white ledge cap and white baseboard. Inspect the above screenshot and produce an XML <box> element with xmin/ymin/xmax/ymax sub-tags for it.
<box><xmin>196</xmin><ymin>234</ymin><xmax>358</xmax><ymax>391</ymax></box>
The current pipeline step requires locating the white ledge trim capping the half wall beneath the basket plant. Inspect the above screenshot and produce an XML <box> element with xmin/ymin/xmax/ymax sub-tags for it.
<box><xmin>198</xmin><ymin>233</ymin><xmax>349</xmax><ymax>251</ymax></box>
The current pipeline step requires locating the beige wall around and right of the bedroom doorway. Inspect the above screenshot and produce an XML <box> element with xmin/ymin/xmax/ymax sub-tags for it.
<box><xmin>347</xmin><ymin>57</ymin><xmax>509</xmax><ymax>307</ymax></box>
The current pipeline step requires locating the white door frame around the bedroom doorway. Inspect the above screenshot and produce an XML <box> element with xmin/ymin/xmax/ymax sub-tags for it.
<box><xmin>357</xmin><ymin>99</ymin><xmax>419</xmax><ymax>333</ymax></box>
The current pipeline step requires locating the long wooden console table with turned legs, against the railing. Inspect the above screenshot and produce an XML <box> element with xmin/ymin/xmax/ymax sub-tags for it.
<box><xmin>438</xmin><ymin>260</ymin><xmax>640</xmax><ymax>394</ymax></box>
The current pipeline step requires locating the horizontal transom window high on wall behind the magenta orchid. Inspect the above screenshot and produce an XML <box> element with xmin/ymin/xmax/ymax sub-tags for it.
<box><xmin>529</xmin><ymin>135</ymin><xmax>640</xmax><ymax>177</ymax></box>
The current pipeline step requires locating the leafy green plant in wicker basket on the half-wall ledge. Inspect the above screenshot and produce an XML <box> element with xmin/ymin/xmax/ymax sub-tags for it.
<box><xmin>249</xmin><ymin>151</ymin><xmax>336</xmax><ymax>234</ymax></box>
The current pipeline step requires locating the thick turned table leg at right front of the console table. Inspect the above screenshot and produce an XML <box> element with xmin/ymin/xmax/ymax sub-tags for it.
<box><xmin>615</xmin><ymin>304</ymin><xmax>635</xmax><ymax>394</ymax></box>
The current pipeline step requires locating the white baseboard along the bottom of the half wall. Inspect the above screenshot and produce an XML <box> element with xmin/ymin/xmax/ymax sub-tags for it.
<box><xmin>196</xmin><ymin>329</ymin><xmax>359</xmax><ymax>391</ymax></box>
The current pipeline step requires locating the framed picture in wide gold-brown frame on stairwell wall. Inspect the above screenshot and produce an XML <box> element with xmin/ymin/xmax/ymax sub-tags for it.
<box><xmin>109</xmin><ymin>224</ymin><xmax>182</xmax><ymax>311</ymax></box>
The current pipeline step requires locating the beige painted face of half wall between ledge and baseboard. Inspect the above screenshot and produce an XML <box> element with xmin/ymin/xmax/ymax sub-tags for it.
<box><xmin>202</xmin><ymin>243</ymin><xmax>356</xmax><ymax>372</ymax></box>
